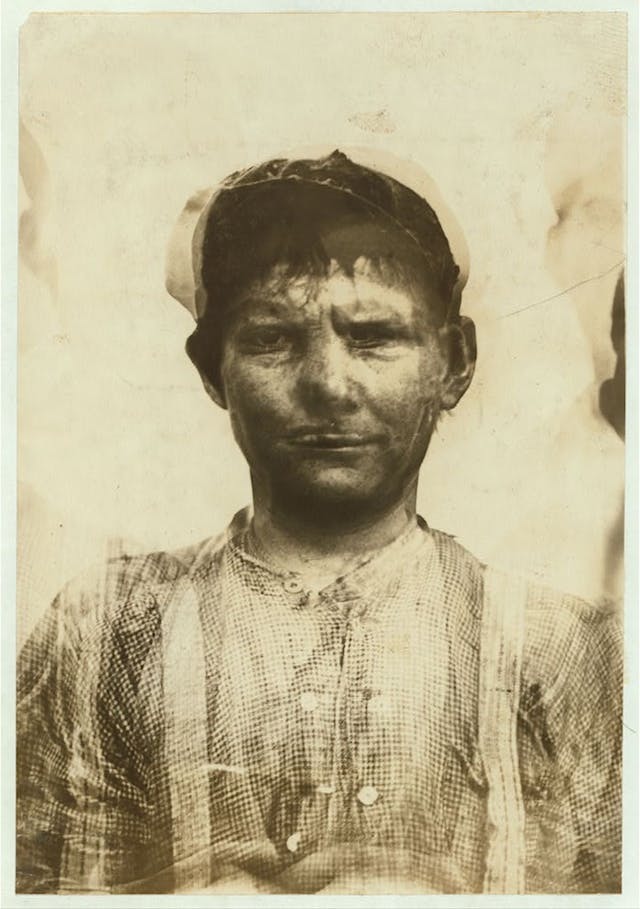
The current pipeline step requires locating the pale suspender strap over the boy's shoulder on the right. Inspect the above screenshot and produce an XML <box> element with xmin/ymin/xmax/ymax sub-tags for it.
<box><xmin>478</xmin><ymin>568</ymin><xmax>527</xmax><ymax>893</ymax></box>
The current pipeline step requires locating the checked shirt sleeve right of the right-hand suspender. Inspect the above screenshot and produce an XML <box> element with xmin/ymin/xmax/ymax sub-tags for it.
<box><xmin>520</xmin><ymin>596</ymin><xmax>623</xmax><ymax>893</ymax></box>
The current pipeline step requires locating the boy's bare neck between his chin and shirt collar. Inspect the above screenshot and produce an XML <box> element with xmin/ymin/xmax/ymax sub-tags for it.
<box><xmin>253</xmin><ymin>477</ymin><xmax>417</xmax><ymax>578</ymax></box>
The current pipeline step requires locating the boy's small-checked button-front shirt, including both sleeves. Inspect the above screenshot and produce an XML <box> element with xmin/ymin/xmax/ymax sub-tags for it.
<box><xmin>17</xmin><ymin>521</ymin><xmax>622</xmax><ymax>893</ymax></box>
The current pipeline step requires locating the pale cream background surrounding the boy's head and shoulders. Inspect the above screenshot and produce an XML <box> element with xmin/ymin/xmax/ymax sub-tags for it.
<box><xmin>18</xmin><ymin>13</ymin><xmax>626</xmax><ymax>640</ymax></box>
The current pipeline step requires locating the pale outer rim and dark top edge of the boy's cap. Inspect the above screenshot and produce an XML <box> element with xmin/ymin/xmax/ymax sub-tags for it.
<box><xmin>166</xmin><ymin>149</ymin><xmax>469</xmax><ymax>320</ymax></box>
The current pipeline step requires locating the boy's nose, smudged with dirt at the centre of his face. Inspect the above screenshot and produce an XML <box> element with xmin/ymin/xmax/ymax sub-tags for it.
<box><xmin>297</xmin><ymin>328</ymin><xmax>357</xmax><ymax>415</ymax></box>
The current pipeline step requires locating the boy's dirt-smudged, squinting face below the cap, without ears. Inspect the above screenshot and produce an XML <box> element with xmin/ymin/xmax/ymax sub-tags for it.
<box><xmin>221</xmin><ymin>225</ymin><xmax>472</xmax><ymax>516</ymax></box>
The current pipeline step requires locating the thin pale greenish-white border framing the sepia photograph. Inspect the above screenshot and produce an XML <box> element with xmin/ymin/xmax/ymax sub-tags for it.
<box><xmin>0</xmin><ymin>0</ymin><xmax>640</xmax><ymax>909</ymax></box>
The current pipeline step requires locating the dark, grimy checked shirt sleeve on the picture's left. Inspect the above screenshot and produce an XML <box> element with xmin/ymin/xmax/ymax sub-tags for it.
<box><xmin>16</xmin><ymin>566</ymin><xmax>162</xmax><ymax>893</ymax></box>
